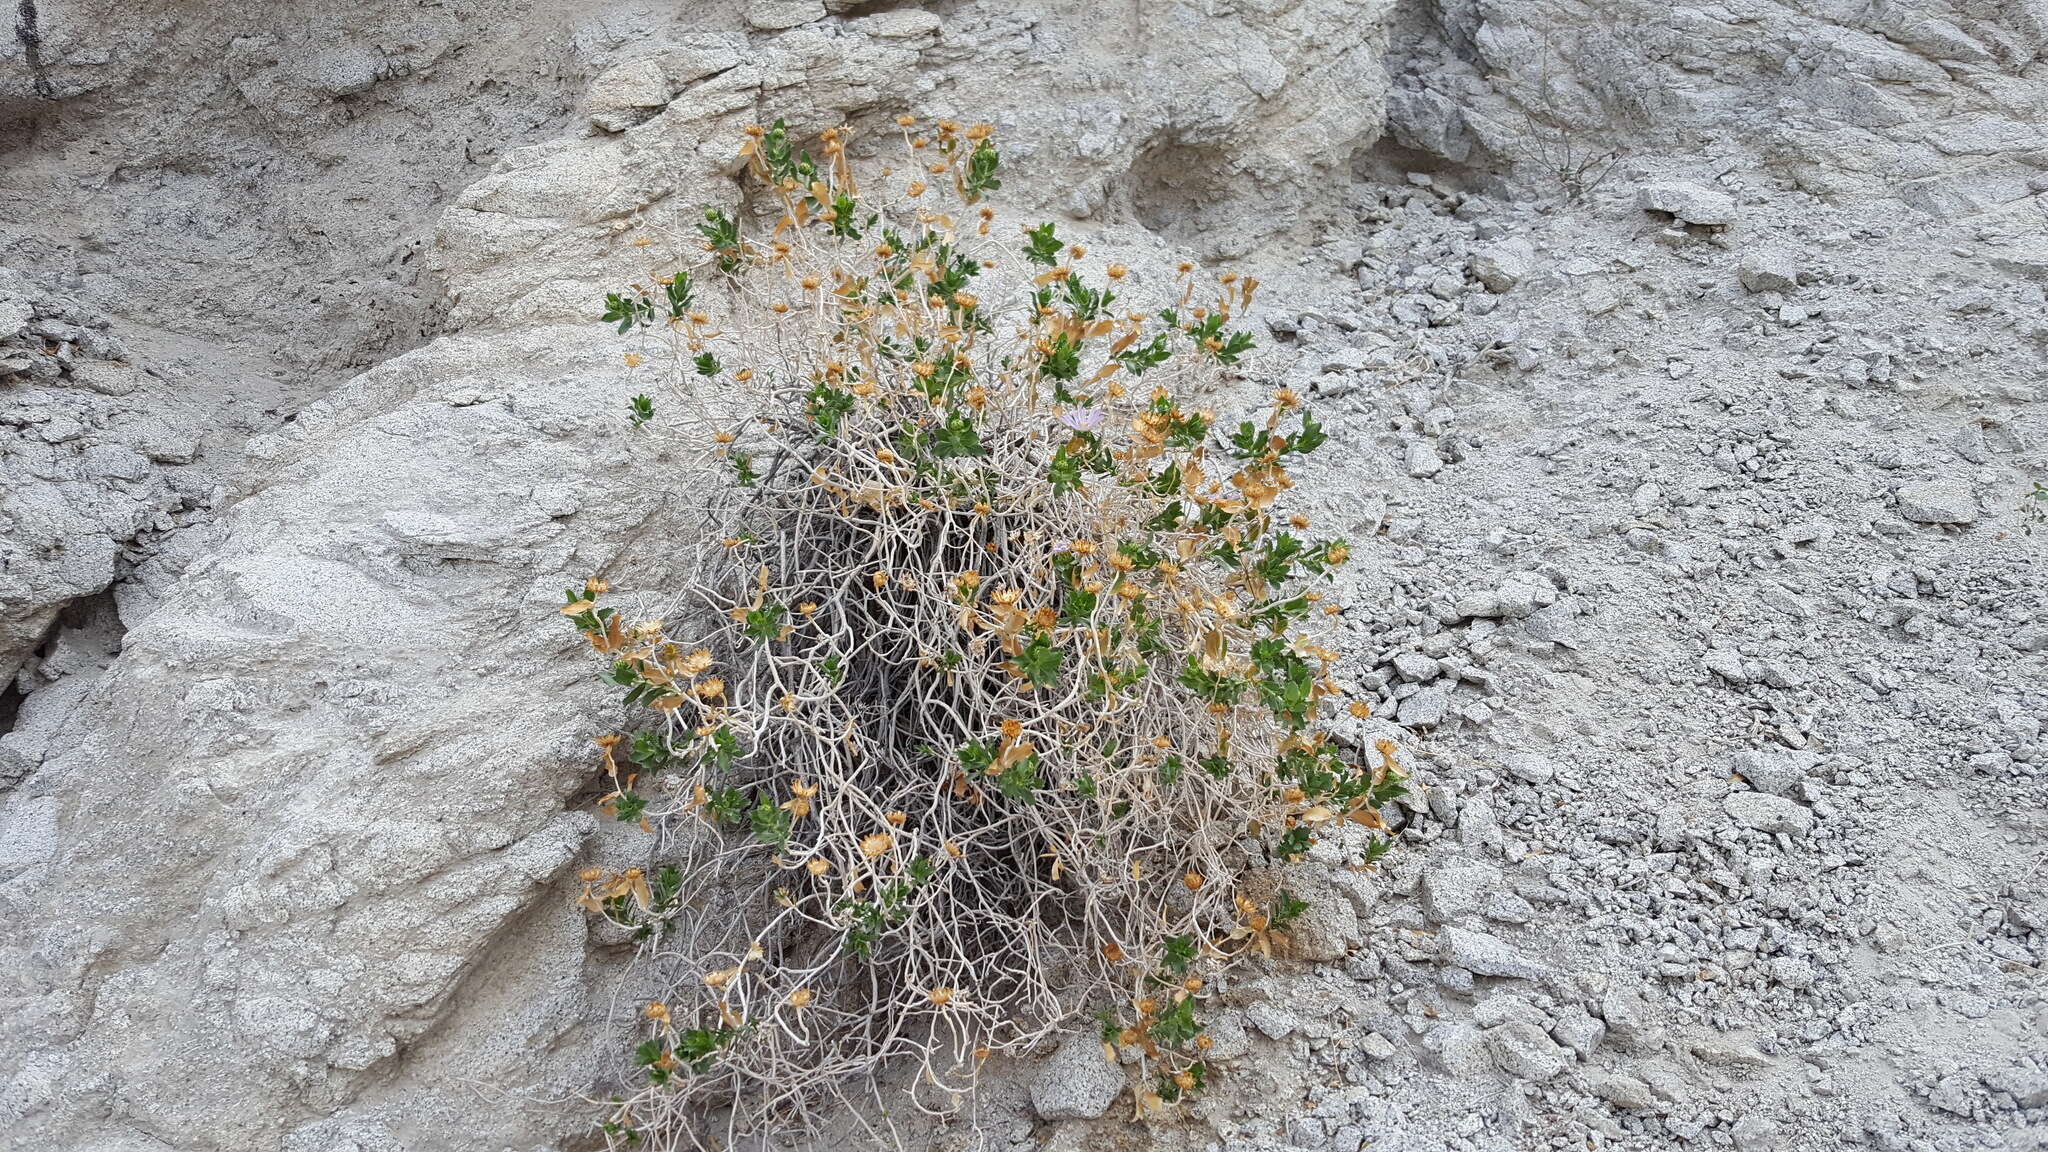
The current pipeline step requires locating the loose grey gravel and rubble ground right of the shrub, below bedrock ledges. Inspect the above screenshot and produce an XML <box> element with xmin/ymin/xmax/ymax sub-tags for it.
<box><xmin>1155</xmin><ymin>160</ymin><xmax>2048</xmax><ymax>1152</ymax></box>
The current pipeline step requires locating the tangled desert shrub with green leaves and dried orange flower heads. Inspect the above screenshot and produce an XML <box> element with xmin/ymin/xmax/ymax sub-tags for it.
<box><xmin>561</xmin><ymin>117</ymin><xmax>1401</xmax><ymax>1148</ymax></box>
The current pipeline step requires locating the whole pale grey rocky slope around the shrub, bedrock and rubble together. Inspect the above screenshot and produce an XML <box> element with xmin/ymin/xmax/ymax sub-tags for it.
<box><xmin>0</xmin><ymin>0</ymin><xmax>2048</xmax><ymax>1152</ymax></box>
